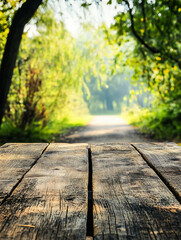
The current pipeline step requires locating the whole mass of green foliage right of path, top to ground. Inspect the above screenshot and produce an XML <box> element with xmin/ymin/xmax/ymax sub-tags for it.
<box><xmin>109</xmin><ymin>0</ymin><xmax>181</xmax><ymax>139</ymax></box>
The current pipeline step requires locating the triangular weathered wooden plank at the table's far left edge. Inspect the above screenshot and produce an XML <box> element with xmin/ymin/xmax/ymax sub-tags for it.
<box><xmin>0</xmin><ymin>143</ymin><xmax>48</xmax><ymax>204</ymax></box>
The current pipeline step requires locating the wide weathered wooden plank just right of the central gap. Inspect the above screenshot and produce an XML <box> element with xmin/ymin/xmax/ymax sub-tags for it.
<box><xmin>91</xmin><ymin>144</ymin><xmax>181</xmax><ymax>240</ymax></box>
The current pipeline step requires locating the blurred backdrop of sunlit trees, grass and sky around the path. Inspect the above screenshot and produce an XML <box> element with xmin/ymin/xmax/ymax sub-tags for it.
<box><xmin>0</xmin><ymin>0</ymin><xmax>181</xmax><ymax>144</ymax></box>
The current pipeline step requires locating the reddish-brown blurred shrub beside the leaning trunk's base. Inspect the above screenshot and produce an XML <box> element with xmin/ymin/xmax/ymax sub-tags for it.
<box><xmin>5</xmin><ymin>60</ymin><xmax>46</xmax><ymax>129</ymax></box>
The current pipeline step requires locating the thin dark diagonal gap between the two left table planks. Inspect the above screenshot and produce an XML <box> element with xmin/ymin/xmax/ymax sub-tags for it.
<box><xmin>0</xmin><ymin>143</ymin><xmax>50</xmax><ymax>206</ymax></box>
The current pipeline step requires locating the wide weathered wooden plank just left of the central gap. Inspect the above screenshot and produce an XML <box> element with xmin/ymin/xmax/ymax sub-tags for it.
<box><xmin>0</xmin><ymin>143</ymin><xmax>88</xmax><ymax>240</ymax></box>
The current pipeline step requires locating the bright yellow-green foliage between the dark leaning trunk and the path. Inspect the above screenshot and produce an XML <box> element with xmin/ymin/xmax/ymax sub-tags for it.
<box><xmin>0</xmin><ymin>9</ymin><xmax>92</xmax><ymax>141</ymax></box>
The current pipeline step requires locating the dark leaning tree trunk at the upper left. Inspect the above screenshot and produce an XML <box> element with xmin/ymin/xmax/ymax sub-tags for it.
<box><xmin>0</xmin><ymin>0</ymin><xmax>42</xmax><ymax>125</ymax></box>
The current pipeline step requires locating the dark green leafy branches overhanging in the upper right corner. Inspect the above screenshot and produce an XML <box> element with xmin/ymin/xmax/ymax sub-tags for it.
<box><xmin>115</xmin><ymin>0</ymin><xmax>181</xmax><ymax>68</ymax></box>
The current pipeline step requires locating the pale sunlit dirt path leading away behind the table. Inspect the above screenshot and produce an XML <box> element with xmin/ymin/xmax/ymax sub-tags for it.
<box><xmin>59</xmin><ymin>115</ymin><xmax>150</xmax><ymax>143</ymax></box>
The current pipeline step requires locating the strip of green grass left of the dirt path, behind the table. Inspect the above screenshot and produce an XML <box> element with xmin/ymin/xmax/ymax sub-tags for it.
<box><xmin>0</xmin><ymin>114</ymin><xmax>91</xmax><ymax>145</ymax></box>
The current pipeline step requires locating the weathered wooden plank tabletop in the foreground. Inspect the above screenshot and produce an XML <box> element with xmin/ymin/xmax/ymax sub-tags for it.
<box><xmin>0</xmin><ymin>143</ymin><xmax>181</xmax><ymax>240</ymax></box>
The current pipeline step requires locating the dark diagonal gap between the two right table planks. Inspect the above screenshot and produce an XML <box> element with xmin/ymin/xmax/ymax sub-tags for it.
<box><xmin>131</xmin><ymin>144</ymin><xmax>181</xmax><ymax>203</ymax></box>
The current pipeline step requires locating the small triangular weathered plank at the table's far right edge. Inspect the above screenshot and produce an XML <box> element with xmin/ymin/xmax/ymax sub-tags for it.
<box><xmin>133</xmin><ymin>143</ymin><xmax>181</xmax><ymax>202</ymax></box>
